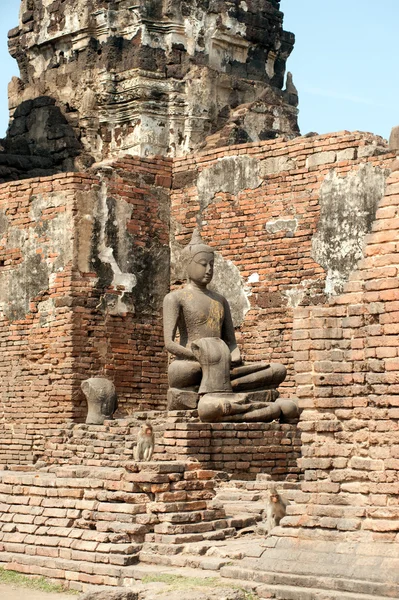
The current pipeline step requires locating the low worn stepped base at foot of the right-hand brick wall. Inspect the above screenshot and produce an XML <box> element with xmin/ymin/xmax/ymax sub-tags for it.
<box><xmin>220</xmin><ymin>528</ymin><xmax>399</xmax><ymax>600</ymax></box>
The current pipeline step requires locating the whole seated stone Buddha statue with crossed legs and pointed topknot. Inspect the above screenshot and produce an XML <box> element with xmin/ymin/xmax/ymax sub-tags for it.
<box><xmin>163</xmin><ymin>230</ymin><xmax>297</xmax><ymax>422</ymax></box>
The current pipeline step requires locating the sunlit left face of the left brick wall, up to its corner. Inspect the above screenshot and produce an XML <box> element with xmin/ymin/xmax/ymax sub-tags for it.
<box><xmin>0</xmin><ymin>175</ymin><xmax>93</xmax><ymax>463</ymax></box>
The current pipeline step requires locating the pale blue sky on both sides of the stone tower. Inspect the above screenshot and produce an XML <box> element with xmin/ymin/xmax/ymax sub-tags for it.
<box><xmin>0</xmin><ymin>0</ymin><xmax>399</xmax><ymax>137</ymax></box>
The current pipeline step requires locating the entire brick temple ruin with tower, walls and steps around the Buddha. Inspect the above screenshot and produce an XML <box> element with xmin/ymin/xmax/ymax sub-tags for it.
<box><xmin>0</xmin><ymin>0</ymin><xmax>399</xmax><ymax>600</ymax></box>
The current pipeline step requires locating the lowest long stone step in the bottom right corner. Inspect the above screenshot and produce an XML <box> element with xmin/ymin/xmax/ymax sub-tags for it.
<box><xmin>220</xmin><ymin>565</ymin><xmax>399</xmax><ymax>600</ymax></box>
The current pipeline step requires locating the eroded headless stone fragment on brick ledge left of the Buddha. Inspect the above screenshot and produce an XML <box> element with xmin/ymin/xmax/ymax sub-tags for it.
<box><xmin>81</xmin><ymin>377</ymin><xmax>118</xmax><ymax>425</ymax></box>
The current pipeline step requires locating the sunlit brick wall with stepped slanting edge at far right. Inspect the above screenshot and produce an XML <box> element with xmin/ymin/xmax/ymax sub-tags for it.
<box><xmin>287</xmin><ymin>168</ymin><xmax>399</xmax><ymax>542</ymax></box>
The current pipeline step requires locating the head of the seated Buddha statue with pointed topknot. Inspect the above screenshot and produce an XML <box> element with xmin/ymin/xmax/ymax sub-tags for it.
<box><xmin>184</xmin><ymin>229</ymin><xmax>215</xmax><ymax>287</ymax></box>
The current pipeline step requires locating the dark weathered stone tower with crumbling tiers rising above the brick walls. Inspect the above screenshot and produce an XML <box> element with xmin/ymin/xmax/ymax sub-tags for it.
<box><xmin>5</xmin><ymin>0</ymin><xmax>298</xmax><ymax>169</ymax></box>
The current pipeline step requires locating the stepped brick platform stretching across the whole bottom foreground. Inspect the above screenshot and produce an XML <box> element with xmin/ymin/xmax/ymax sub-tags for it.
<box><xmin>0</xmin><ymin>461</ymin><xmax>399</xmax><ymax>600</ymax></box>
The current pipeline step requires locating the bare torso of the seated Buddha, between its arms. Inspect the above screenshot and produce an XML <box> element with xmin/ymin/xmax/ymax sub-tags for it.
<box><xmin>176</xmin><ymin>284</ymin><xmax>224</xmax><ymax>346</ymax></box>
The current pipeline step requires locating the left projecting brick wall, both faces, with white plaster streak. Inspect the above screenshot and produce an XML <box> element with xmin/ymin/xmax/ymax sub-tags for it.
<box><xmin>0</xmin><ymin>158</ymin><xmax>170</xmax><ymax>464</ymax></box>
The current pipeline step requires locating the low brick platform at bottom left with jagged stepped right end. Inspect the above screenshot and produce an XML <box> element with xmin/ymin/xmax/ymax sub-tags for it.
<box><xmin>0</xmin><ymin>461</ymin><xmax>231</xmax><ymax>586</ymax></box>
